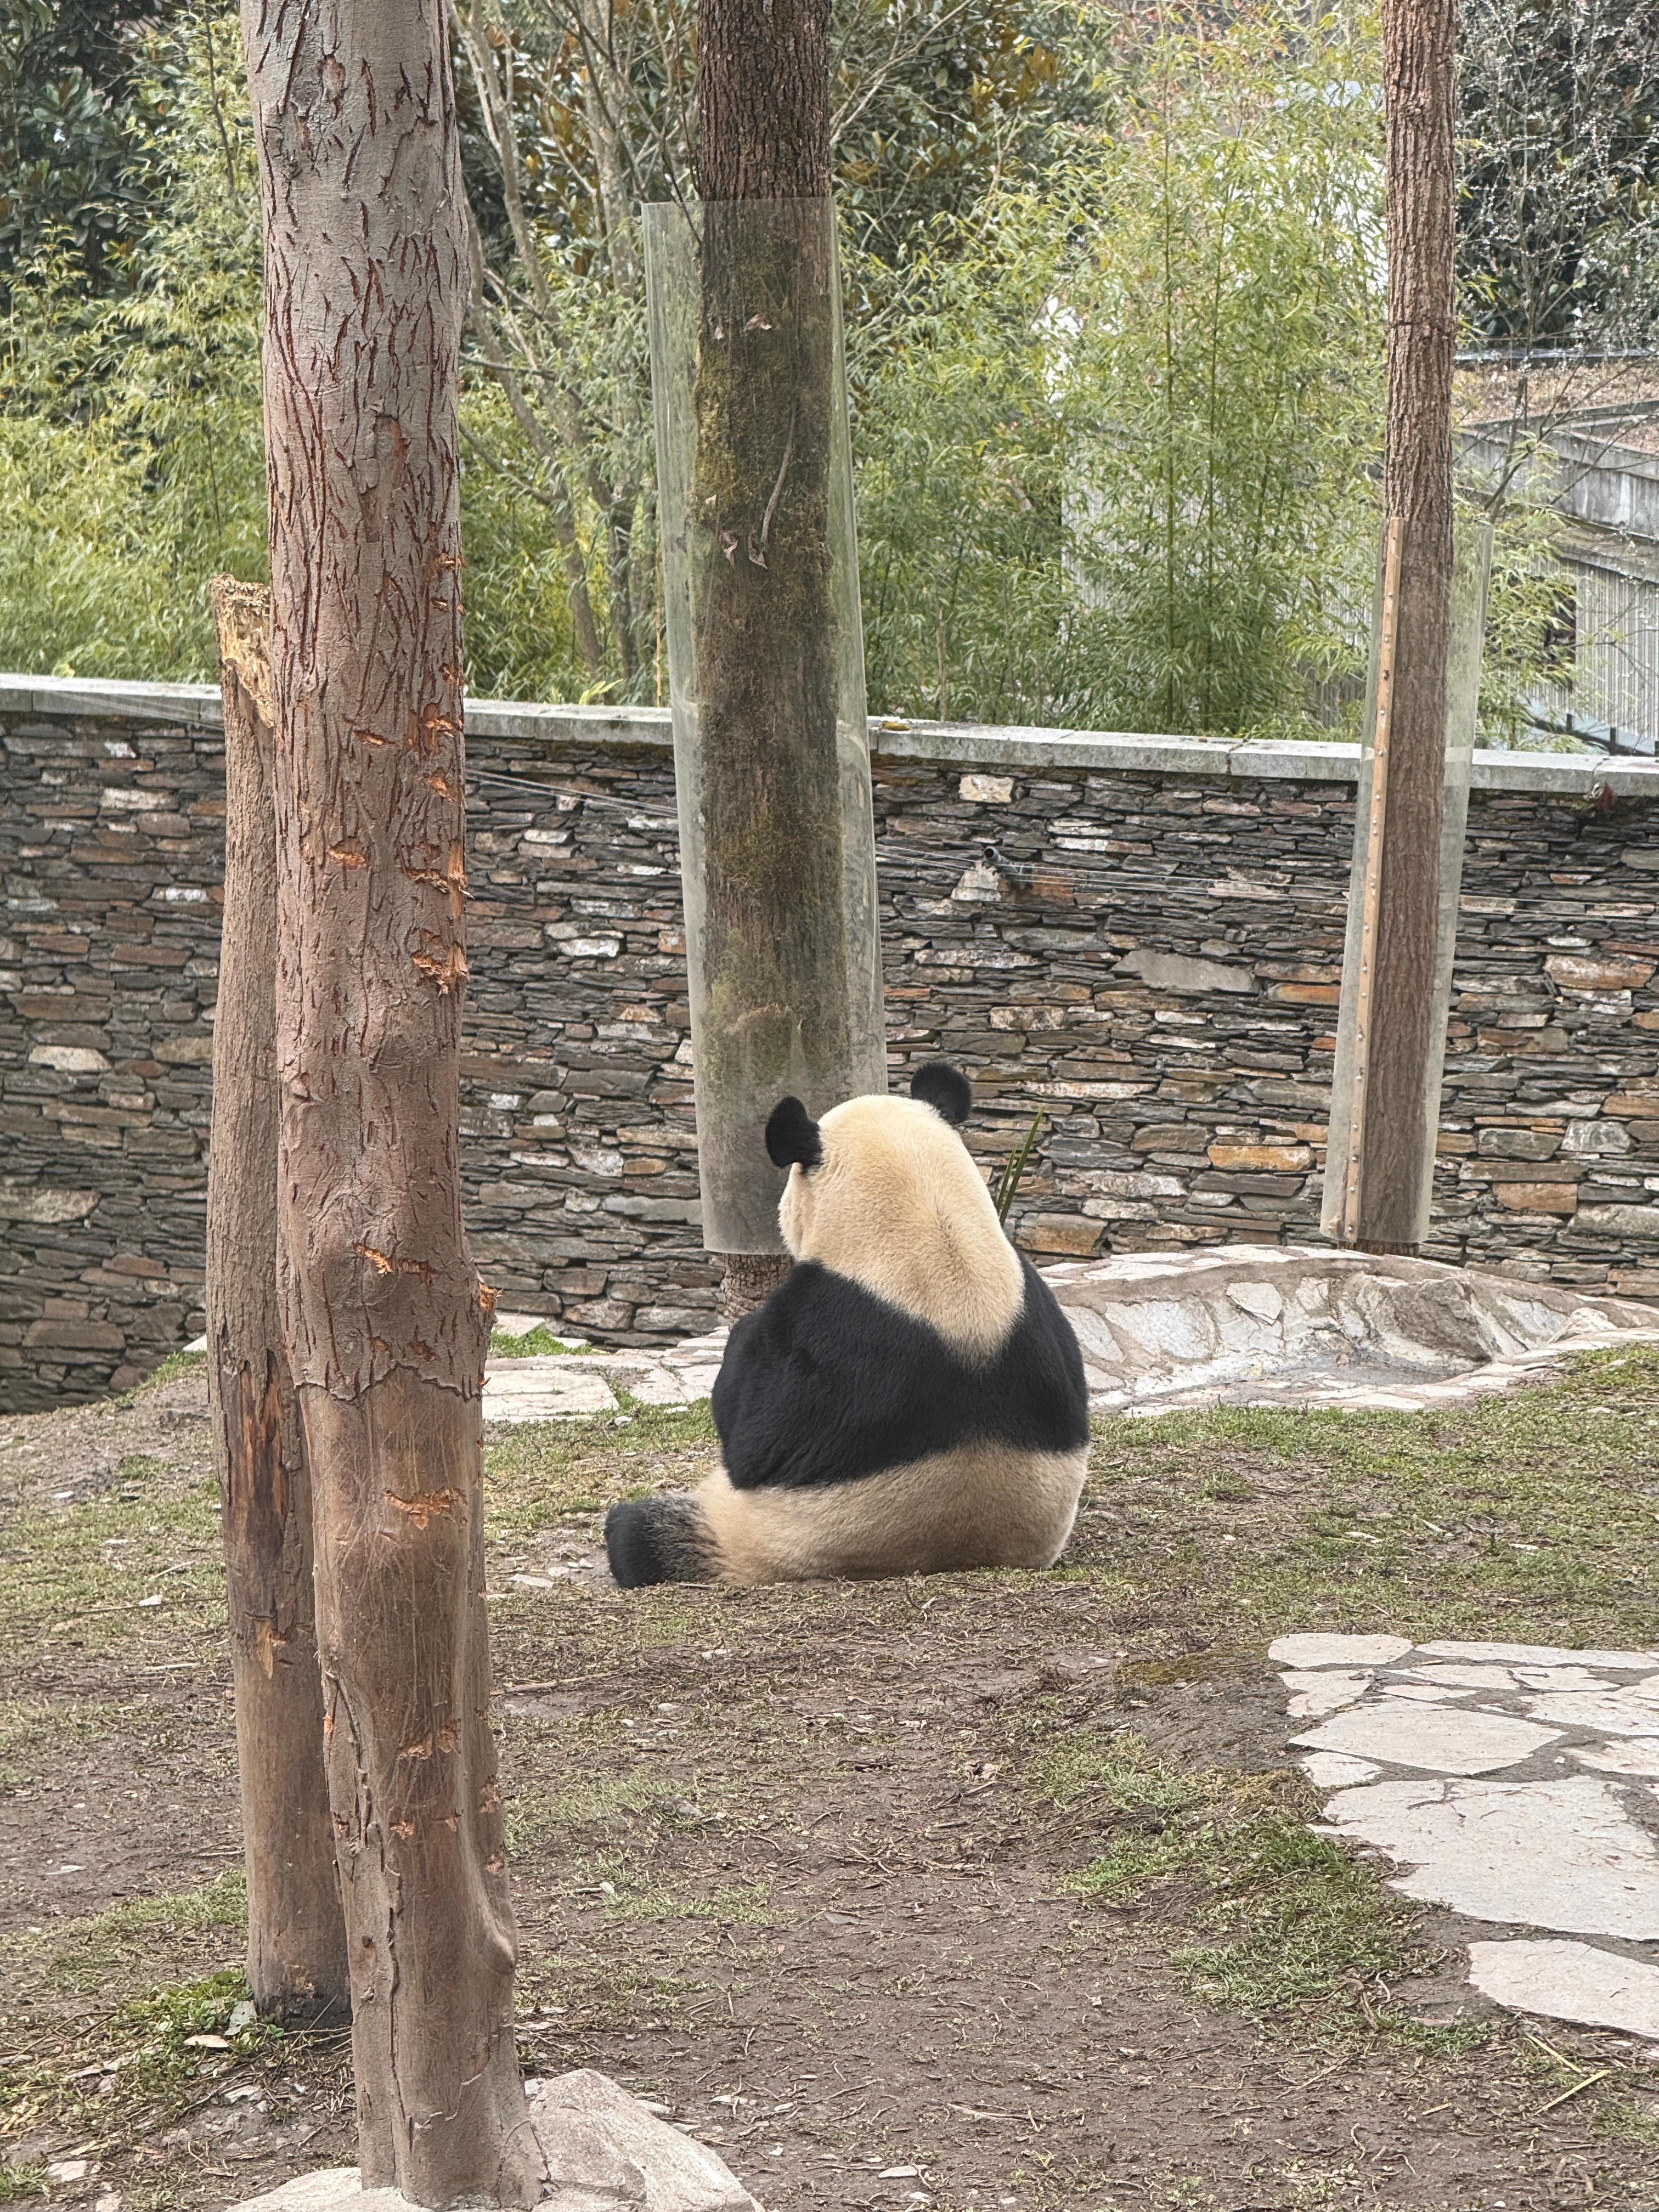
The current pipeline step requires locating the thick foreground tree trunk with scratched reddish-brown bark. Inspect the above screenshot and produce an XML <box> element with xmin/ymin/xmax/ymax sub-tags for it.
<box><xmin>244</xmin><ymin>0</ymin><xmax>542</xmax><ymax>2205</ymax></box>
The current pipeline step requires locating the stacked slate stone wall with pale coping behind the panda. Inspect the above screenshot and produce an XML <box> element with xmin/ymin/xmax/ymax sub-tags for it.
<box><xmin>0</xmin><ymin>679</ymin><xmax>1659</xmax><ymax>1407</ymax></box>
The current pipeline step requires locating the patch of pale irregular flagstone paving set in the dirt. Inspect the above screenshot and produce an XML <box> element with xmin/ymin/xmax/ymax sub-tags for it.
<box><xmin>1267</xmin><ymin>1633</ymin><xmax>1659</xmax><ymax>2044</ymax></box>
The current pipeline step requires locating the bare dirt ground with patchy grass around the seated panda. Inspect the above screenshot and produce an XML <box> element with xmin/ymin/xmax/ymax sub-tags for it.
<box><xmin>0</xmin><ymin>1354</ymin><xmax>1659</xmax><ymax>2212</ymax></box>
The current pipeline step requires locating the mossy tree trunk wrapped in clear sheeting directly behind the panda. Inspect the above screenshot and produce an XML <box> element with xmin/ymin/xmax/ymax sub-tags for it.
<box><xmin>688</xmin><ymin>0</ymin><xmax>885</xmax><ymax>1318</ymax></box>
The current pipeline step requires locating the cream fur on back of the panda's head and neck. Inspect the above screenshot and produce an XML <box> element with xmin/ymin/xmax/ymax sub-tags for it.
<box><xmin>778</xmin><ymin>1097</ymin><xmax>1024</xmax><ymax>1358</ymax></box>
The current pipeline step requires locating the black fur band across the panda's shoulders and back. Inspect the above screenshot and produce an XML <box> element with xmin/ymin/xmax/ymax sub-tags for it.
<box><xmin>712</xmin><ymin>1259</ymin><xmax>1088</xmax><ymax>1491</ymax></box>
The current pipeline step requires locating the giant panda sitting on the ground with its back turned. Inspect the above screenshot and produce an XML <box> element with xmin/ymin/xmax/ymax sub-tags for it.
<box><xmin>604</xmin><ymin>1062</ymin><xmax>1088</xmax><ymax>1588</ymax></box>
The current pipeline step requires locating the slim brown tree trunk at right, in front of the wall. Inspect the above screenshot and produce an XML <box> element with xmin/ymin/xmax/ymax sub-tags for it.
<box><xmin>1354</xmin><ymin>0</ymin><xmax>1455</xmax><ymax>1252</ymax></box>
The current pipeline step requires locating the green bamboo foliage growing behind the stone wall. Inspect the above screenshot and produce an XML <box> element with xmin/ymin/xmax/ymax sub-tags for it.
<box><xmin>0</xmin><ymin>0</ymin><xmax>1555</xmax><ymax>739</ymax></box>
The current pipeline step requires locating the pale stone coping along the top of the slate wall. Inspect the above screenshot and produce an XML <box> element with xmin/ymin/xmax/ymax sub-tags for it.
<box><xmin>0</xmin><ymin>675</ymin><xmax>1659</xmax><ymax>799</ymax></box>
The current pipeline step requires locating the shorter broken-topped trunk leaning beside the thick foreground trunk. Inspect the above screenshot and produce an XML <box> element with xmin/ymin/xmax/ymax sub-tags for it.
<box><xmin>208</xmin><ymin>575</ymin><xmax>352</xmax><ymax>2024</ymax></box>
